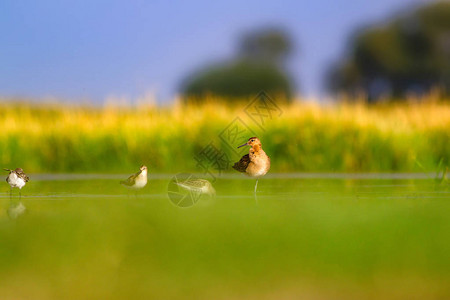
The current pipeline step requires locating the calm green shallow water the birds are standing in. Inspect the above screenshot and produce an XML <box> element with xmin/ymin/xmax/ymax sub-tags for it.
<box><xmin>0</xmin><ymin>173</ymin><xmax>450</xmax><ymax>299</ymax></box>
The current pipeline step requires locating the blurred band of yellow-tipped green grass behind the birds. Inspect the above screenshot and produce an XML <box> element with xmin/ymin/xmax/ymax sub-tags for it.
<box><xmin>0</xmin><ymin>100</ymin><xmax>450</xmax><ymax>173</ymax></box>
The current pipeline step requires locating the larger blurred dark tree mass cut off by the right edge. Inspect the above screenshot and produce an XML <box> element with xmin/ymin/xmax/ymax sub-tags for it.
<box><xmin>327</xmin><ymin>1</ymin><xmax>450</xmax><ymax>100</ymax></box>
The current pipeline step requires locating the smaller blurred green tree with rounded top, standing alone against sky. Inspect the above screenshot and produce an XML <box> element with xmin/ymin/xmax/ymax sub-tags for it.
<box><xmin>182</xmin><ymin>29</ymin><xmax>292</xmax><ymax>100</ymax></box>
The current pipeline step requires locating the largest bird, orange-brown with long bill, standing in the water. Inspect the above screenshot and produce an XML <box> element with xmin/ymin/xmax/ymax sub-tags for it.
<box><xmin>233</xmin><ymin>137</ymin><xmax>270</xmax><ymax>196</ymax></box>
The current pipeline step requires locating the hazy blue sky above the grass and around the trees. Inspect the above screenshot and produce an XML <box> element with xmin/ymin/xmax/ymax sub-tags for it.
<box><xmin>0</xmin><ymin>0</ymin><xmax>423</xmax><ymax>102</ymax></box>
